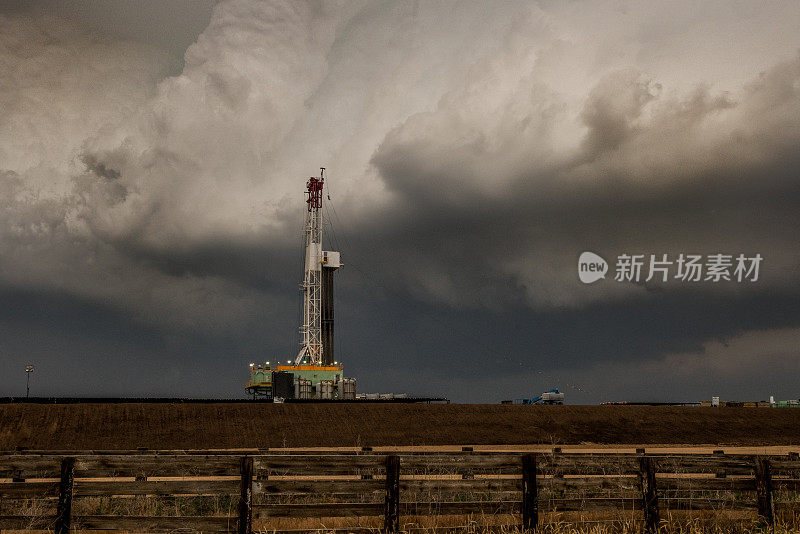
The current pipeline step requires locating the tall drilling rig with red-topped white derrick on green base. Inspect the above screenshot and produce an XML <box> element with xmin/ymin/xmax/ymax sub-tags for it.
<box><xmin>245</xmin><ymin>167</ymin><xmax>356</xmax><ymax>402</ymax></box>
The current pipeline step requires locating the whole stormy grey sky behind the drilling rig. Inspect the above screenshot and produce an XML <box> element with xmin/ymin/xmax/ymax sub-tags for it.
<box><xmin>0</xmin><ymin>0</ymin><xmax>800</xmax><ymax>403</ymax></box>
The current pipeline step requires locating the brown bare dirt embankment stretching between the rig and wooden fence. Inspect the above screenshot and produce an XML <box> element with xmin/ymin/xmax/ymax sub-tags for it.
<box><xmin>0</xmin><ymin>403</ymin><xmax>800</xmax><ymax>450</ymax></box>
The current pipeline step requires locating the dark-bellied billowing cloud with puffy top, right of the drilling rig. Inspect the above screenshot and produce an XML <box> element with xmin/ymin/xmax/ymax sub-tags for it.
<box><xmin>373</xmin><ymin>58</ymin><xmax>800</xmax><ymax>312</ymax></box>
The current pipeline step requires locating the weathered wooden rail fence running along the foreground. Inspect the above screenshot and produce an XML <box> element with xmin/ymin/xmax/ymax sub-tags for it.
<box><xmin>0</xmin><ymin>447</ymin><xmax>800</xmax><ymax>534</ymax></box>
